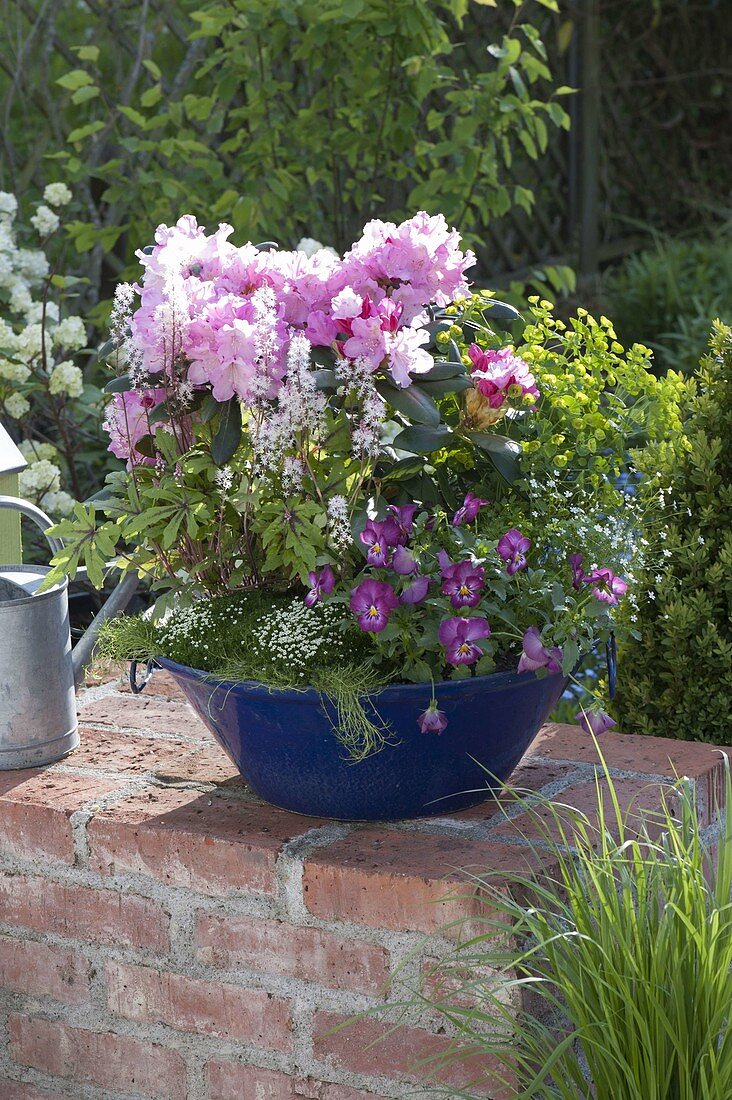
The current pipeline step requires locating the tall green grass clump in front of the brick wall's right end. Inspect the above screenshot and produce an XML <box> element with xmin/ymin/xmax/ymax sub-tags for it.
<box><xmin>391</xmin><ymin>760</ymin><xmax>732</xmax><ymax>1100</ymax></box>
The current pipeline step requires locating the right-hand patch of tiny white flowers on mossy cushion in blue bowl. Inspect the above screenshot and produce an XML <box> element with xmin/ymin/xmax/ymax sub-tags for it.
<box><xmin>256</xmin><ymin>600</ymin><xmax>347</xmax><ymax>679</ymax></box>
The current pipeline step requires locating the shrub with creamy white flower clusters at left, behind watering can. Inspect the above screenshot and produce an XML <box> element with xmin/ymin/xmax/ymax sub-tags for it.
<box><xmin>0</xmin><ymin>183</ymin><xmax>103</xmax><ymax>517</ymax></box>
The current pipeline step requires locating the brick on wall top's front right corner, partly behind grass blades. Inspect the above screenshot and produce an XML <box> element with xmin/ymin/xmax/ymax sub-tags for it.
<box><xmin>493</xmin><ymin>779</ymin><xmax>673</xmax><ymax>843</ymax></box>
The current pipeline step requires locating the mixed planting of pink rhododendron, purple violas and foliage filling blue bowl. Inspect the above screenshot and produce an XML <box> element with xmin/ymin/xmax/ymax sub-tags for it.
<box><xmin>50</xmin><ymin>212</ymin><xmax>674</xmax><ymax>740</ymax></box>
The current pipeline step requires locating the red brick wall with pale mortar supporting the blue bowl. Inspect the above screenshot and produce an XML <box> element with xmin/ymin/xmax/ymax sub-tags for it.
<box><xmin>0</xmin><ymin>673</ymin><xmax>721</xmax><ymax>1100</ymax></box>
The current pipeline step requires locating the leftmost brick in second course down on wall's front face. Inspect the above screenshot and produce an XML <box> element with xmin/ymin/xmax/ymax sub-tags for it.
<box><xmin>0</xmin><ymin>872</ymin><xmax>170</xmax><ymax>950</ymax></box>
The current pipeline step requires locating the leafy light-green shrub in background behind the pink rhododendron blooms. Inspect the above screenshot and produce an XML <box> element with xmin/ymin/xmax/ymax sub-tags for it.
<box><xmin>42</xmin><ymin>0</ymin><xmax>569</xmax><ymax>272</ymax></box>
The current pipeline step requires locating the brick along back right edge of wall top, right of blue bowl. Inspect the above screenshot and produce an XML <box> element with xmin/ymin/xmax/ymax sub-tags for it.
<box><xmin>532</xmin><ymin>724</ymin><xmax>732</xmax><ymax>824</ymax></box>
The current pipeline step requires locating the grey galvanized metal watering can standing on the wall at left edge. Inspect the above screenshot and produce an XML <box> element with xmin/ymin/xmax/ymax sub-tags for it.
<box><xmin>0</xmin><ymin>496</ymin><xmax>136</xmax><ymax>770</ymax></box>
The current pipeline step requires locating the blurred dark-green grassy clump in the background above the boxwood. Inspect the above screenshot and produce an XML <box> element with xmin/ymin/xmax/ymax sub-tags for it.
<box><xmin>604</xmin><ymin>232</ymin><xmax>732</xmax><ymax>374</ymax></box>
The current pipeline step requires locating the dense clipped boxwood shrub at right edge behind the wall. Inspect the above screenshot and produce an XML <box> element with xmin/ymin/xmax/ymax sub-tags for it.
<box><xmin>614</xmin><ymin>321</ymin><xmax>732</xmax><ymax>745</ymax></box>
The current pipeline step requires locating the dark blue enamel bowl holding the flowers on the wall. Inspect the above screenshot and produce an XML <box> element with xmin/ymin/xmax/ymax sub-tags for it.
<box><xmin>156</xmin><ymin>657</ymin><xmax>567</xmax><ymax>821</ymax></box>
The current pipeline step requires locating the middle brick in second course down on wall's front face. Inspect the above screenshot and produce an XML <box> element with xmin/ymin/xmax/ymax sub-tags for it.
<box><xmin>194</xmin><ymin>913</ymin><xmax>389</xmax><ymax>993</ymax></box>
